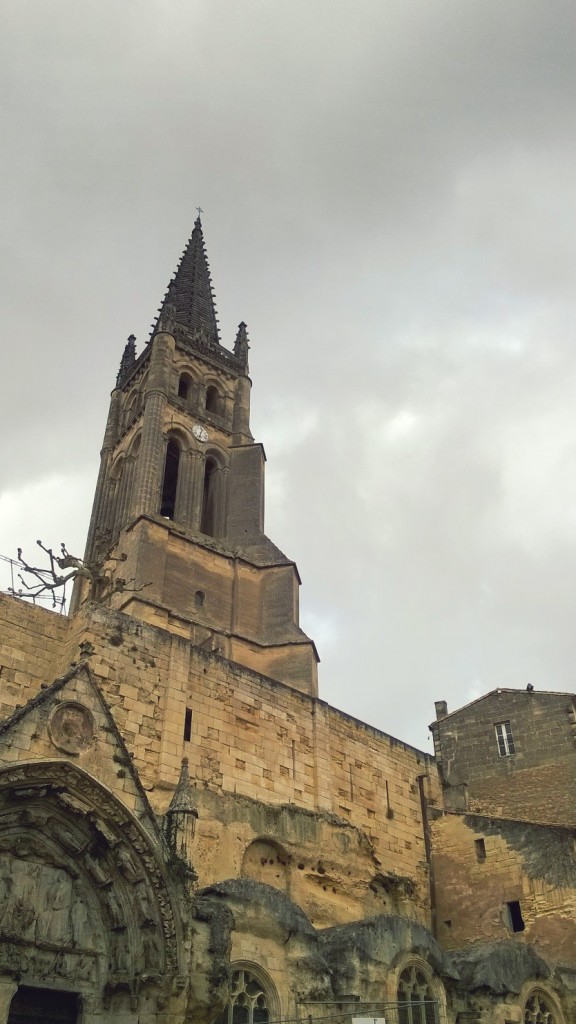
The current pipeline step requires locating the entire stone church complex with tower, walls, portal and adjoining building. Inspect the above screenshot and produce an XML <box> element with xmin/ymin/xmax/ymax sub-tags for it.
<box><xmin>0</xmin><ymin>220</ymin><xmax>576</xmax><ymax>1024</ymax></box>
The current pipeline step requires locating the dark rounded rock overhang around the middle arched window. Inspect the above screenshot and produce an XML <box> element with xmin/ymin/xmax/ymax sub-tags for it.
<box><xmin>319</xmin><ymin>914</ymin><xmax>450</xmax><ymax>999</ymax></box>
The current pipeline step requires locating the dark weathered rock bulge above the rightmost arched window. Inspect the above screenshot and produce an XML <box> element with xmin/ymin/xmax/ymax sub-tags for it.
<box><xmin>446</xmin><ymin>939</ymin><xmax>550</xmax><ymax>995</ymax></box>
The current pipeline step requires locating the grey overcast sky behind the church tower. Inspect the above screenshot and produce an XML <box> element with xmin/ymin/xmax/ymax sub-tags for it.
<box><xmin>0</xmin><ymin>0</ymin><xmax>576</xmax><ymax>750</ymax></box>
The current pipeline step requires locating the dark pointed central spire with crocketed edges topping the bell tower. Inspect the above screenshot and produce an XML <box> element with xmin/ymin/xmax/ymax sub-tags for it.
<box><xmin>157</xmin><ymin>216</ymin><xmax>220</xmax><ymax>348</ymax></box>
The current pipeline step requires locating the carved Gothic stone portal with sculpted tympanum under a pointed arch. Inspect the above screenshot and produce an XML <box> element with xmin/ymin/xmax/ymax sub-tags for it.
<box><xmin>0</xmin><ymin>762</ymin><xmax>176</xmax><ymax>1024</ymax></box>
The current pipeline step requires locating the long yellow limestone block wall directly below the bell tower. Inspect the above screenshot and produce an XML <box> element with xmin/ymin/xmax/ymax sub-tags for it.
<box><xmin>0</xmin><ymin>597</ymin><xmax>435</xmax><ymax>927</ymax></box>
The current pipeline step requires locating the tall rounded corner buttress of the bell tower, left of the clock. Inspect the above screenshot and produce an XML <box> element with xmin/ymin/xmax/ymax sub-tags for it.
<box><xmin>132</xmin><ymin>331</ymin><xmax>175</xmax><ymax>515</ymax></box>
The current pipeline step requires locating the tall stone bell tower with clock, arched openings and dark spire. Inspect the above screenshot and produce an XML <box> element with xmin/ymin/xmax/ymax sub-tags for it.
<box><xmin>77</xmin><ymin>217</ymin><xmax>318</xmax><ymax>694</ymax></box>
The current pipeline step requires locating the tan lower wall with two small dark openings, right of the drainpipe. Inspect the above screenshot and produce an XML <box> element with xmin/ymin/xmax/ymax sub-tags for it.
<box><xmin>431</xmin><ymin>813</ymin><xmax>576</xmax><ymax>968</ymax></box>
